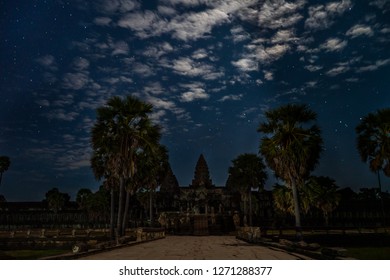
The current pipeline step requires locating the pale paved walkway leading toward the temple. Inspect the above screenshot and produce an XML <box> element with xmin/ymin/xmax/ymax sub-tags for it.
<box><xmin>83</xmin><ymin>236</ymin><xmax>309</xmax><ymax>260</ymax></box>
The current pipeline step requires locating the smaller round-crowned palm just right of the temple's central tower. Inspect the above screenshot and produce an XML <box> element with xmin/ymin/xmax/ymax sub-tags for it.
<box><xmin>228</xmin><ymin>153</ymin><xmax>267</xmax><ymax>226</ymax></box>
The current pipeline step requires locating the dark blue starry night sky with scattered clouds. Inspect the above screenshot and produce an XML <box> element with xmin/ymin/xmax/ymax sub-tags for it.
<box><xmin>0</xmin><ymin>0</ymin><xmax>390</xmax><ymax>201</ymax></box>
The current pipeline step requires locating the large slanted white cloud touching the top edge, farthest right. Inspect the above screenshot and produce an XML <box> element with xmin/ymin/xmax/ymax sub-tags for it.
<box><xmin>305</xmin><ymin>0</ymin><xmax>352</xmax><ymax>30</ymax></box>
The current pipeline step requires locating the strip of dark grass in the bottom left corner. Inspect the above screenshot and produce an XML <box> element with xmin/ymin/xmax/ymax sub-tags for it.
<box><xmin>0</xmin><ymin>249</ymin><xmax>69</xmax><ymax>260</ymax></box>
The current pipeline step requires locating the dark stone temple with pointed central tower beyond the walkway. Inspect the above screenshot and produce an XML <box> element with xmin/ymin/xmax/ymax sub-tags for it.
<box><xmin>156</xmin><ymin>154</ymin><xmax>272</xmax><ymax>229</ymax></box>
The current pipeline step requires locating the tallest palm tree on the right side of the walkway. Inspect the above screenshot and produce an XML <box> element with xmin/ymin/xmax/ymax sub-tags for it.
<box><xmin>258</xmin><ymin>104</ymin><xmax>323</xmax><ymax>238</ymax></box>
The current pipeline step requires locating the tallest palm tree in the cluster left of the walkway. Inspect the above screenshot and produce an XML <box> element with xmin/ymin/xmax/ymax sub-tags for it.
<box><xmin>92</xmin><ymin>96</ymin><xmax>161</xmax><ymax>235</ymax></box>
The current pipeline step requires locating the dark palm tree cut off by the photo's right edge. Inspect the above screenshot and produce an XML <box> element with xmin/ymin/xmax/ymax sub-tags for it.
<box><xmin>355</xmin><ymin>108</ymin><xmax>390</xmax><ymax>192</ymax></box>
